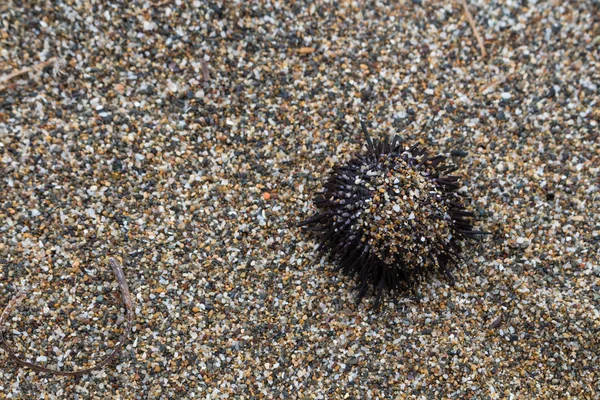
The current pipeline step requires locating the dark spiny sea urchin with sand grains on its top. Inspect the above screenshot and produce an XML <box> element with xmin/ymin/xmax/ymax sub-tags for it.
<box><xmin>298</xmin><ymin>121</ymin><xmax>487</xmax><ymax>307</ymax></box>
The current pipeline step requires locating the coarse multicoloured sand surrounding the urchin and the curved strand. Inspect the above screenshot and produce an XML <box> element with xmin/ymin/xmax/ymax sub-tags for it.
<box><xmin>0</xmin><ymin>0</ymin><xmax>600</xmax><ymax>399</ymax></box>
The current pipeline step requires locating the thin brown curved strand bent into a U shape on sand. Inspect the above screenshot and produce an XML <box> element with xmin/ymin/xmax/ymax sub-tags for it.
<box><xmin>0</xmin><ymin>258</ymin><xmax>135</xmax><ymax>376</ymax></box>
